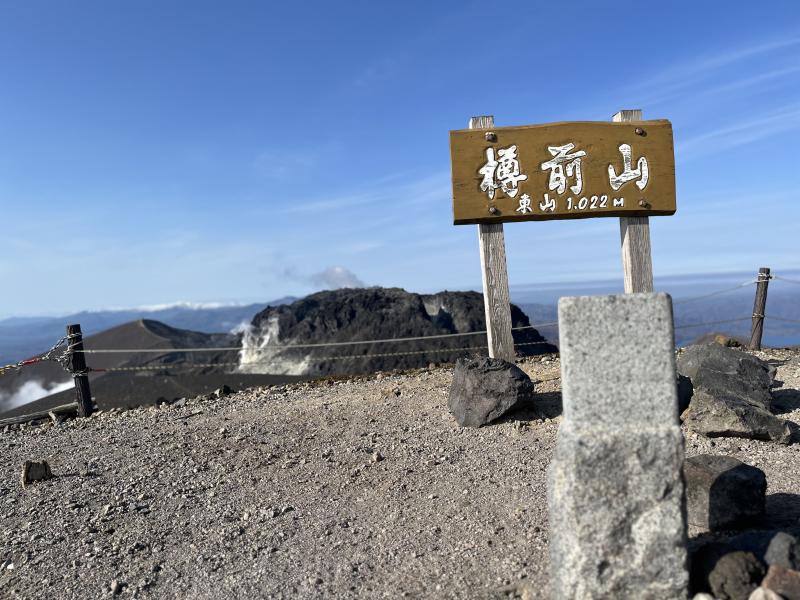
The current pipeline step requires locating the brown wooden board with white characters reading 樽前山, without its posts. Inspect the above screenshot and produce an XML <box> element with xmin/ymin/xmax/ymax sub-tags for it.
<box><xmin>450</xmin><ymin>120</ymin><xmax>676</xmax><ymax>225</ymax></box>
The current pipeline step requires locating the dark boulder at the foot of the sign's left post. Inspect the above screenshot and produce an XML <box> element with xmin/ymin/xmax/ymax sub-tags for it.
<box><xmin>448</xmin><ymin>357</ymin><xmax>533</xmax><ymax>427</ymax></box>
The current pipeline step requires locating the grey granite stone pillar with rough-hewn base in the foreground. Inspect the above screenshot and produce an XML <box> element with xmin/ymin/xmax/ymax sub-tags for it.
<box><xmin>548</xmin><ymin>294</ymin><xmax>689</xmax><ymax>600</ymax></box>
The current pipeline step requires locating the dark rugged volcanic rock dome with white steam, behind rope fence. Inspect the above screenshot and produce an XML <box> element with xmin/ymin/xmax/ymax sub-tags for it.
<box><xmin>242</xmin><ymin>287</ymin><xmax>556</xmax><ymax>375</ymax></box>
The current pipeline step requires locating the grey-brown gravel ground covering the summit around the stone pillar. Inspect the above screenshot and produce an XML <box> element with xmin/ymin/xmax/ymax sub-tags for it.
<box><xmin>0</xmin><ymin>351</ymin><xmax>800</xmax><ymax>598</ymax></box>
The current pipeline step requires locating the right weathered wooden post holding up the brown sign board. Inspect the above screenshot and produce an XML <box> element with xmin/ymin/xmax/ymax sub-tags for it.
<box><xmin>611</xmin><ymin>109</ymin><xmax>653</xmax><ymax>294</ymax></box>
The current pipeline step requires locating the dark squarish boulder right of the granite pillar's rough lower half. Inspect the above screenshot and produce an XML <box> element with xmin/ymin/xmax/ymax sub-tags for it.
<box><xmin>683</xmin><ymin>454</ymin><xmax>767</xmax><ymax>531</ymax></box>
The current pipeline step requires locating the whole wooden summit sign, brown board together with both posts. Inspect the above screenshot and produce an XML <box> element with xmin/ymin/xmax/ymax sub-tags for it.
<box><xmin>450</xmin><ymin>110</ymin><xmax>676</xmax><ymax>360</ymax></box>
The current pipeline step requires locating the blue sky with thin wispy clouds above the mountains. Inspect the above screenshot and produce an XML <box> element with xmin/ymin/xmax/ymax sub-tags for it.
<box><xmin>0</xmin><ymin>0</ymin><xmax>800</xmax><ymax>317</ymax></box>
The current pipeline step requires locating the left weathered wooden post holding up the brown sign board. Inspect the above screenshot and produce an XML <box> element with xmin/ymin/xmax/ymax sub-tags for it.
<box><xmin>469</xmin><ymin>116</ymin><xmax>514</xmax><ymax>362</ymax></box>
